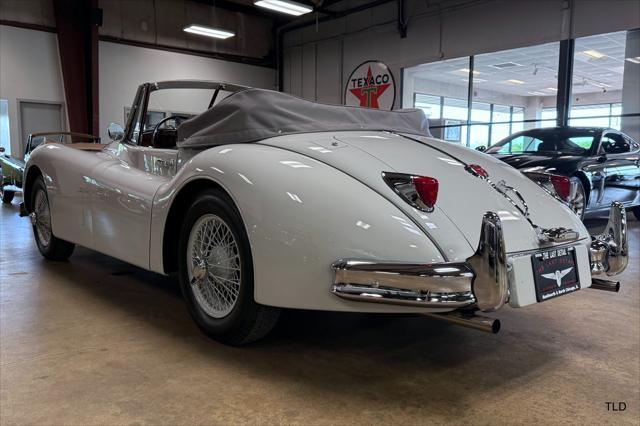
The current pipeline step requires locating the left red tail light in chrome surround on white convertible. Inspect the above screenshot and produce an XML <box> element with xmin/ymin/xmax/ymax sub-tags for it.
<box><xmin>382</xmin><ymin>172</ymin><xmax>438</xmax><ymax>212</ymax></box>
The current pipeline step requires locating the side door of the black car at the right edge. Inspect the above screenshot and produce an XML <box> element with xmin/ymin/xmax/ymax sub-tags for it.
<box><xmin>598</xmin><ymin>131</ymin><xmax>640</xmax><ymax>207</ymax></box>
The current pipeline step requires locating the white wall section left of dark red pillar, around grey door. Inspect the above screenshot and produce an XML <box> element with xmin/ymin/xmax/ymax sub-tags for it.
<box><xmin>0</xmin><ymin>25</ymin><xmax>64</xmax><ymax>156</ymax></box>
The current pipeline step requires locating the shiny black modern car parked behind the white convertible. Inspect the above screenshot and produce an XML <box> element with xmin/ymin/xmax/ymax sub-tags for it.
<box><xmin>485</xmin><ymin>127</ymin><xmax>640</xmax><ymax>219</ymax></box>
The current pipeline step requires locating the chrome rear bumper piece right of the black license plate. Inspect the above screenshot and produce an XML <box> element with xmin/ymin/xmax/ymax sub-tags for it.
<box><xmin>589</xmin><ymin>201</ymin><xmax>629</xmax><ymax>276</ymax></box>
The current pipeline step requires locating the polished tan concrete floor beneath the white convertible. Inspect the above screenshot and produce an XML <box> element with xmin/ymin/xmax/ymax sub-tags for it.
<box><xmin>0</xmin><ymin>197</ymin><xmax>640</xmax><ymax>425</ymax></box>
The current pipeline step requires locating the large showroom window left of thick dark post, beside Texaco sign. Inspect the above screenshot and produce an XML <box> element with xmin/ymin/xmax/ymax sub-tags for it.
<box><xmin>403</xmin><ymin>43</ymin><xmax>559</xmax><ymax>147</ymax></box>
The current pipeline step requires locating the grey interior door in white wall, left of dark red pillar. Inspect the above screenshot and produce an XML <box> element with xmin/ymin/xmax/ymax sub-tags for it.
<box><xmin>19</xmin><ymin>101</ymin><xmax>64</xmax><ymax>158</ymax></box>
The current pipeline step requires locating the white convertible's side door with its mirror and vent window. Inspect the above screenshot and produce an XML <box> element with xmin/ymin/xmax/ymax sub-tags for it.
<box><xmin>92</xmin><ymin>87</ymin><xmax>178</xmax><ymax>268</ymax></box>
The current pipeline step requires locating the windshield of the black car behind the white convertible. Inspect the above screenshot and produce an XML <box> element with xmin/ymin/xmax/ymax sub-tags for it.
<box><xmin>486</xmin><ymin>129</ymin><xmax>597</xmax><ymax>155</ymax></box>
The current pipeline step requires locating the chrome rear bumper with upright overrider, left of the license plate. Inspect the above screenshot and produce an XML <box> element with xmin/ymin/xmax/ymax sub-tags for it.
<box><xmin>331</xmin><ymin>212</ymin><xmax>509</xmax><ymax>312</ymax></box>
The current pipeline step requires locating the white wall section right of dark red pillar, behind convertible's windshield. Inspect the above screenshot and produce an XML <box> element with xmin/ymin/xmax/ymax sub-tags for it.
<box><xmin>99</xmin><ymin>41</ymin><xmax>276</xmax><ymax>140</ymax></box>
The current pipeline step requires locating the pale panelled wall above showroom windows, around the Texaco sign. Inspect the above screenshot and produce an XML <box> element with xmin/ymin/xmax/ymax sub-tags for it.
<box><xmin>283</xmin><ymin>0</ymin><xmax>640</xmax><ymax>107</ymax></box>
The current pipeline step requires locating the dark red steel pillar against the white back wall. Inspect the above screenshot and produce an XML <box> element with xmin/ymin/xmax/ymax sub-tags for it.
<box><xmin>53</xmin><ymin>0</ymin><xmax>100</xmax><ymax>135</ymax></box>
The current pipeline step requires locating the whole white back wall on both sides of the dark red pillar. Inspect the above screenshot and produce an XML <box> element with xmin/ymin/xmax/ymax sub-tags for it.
<box><xmin>0</xmin><ymin>25</ymin><xmax>276</xmax><ymax>150</ymax></box>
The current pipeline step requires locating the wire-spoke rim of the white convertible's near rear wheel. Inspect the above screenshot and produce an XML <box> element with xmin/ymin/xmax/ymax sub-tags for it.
<box><xmin>186</xmin><ymin>214</ymin><xmax>242</xmax><ymax>318</ymax></box>
